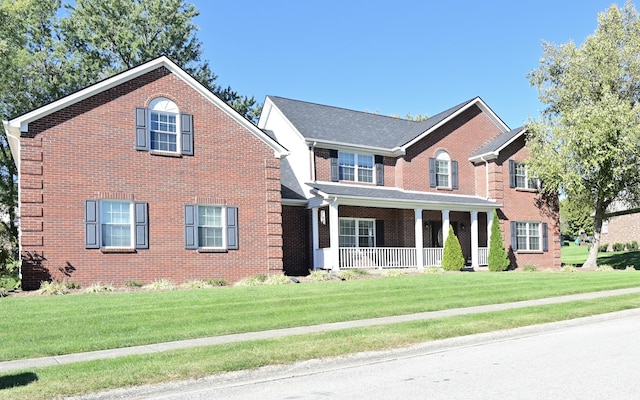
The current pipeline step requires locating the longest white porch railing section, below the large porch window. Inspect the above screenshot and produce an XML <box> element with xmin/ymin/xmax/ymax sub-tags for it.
<box><xmin>339</xmin><ymin>247</ymin><xmax>417</xmax><ymax>269</ymax></box>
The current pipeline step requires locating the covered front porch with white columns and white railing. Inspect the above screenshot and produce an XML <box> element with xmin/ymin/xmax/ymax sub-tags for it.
<box><xmin>309</xmin><ymin>185</ymin><xmax>499</xmax><ymax>270</ymax></box>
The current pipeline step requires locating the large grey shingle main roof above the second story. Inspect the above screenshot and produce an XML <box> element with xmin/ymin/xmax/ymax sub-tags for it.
<box><xmin>269</xmin><ymin>96</ymin><xmax>475</xmax><ymax>149</ymax></box>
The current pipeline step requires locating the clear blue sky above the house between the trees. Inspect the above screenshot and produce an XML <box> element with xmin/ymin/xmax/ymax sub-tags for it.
<box><xmin>191</xmin><ymin>0</ymin><xmax>624</xmax><ymax>128</ymax></box>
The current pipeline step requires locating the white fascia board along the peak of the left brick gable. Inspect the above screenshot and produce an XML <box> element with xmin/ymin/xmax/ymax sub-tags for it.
<box><xmin>9</xmin><ymin>56</ymin><xmax>289</xmax><ymax>158</ymax></box>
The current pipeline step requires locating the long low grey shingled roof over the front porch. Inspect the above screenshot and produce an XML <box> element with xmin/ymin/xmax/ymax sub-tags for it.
<box><xmin>307</xmin><ymin>182</ymin><xmax>501</xmax><ymax>211</ymax></box>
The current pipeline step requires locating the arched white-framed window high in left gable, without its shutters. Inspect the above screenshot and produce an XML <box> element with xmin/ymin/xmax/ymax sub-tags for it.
<box><xmin>149</xmin><ymin>97</ymin><xmax>180</xmax><ymax>153</ymax></box>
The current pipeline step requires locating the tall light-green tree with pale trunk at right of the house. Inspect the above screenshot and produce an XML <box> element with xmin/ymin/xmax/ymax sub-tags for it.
<box><xmin>527</xmin><ymin>2</ymin><xmax>640</xmax><ymax>268</ymax></box>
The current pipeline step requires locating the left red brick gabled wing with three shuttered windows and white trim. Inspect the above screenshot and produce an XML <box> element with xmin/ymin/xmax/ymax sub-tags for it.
<box><xmin>4</xmin><ymin>57</ymin><xmax>288</xmax><ymax>289</ymax></box>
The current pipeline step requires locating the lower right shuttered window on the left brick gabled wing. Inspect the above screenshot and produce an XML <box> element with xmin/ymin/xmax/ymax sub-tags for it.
<box><xmin>184</xmin><ymin>204</ymin><xmax>238</xmax><ymax>251</ymax></box>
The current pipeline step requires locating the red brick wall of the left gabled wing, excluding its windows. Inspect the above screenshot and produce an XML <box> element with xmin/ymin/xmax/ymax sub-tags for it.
<box><xmin>20</xmin><ymin>68</ymin><xmax>282</xmax><ymax>289</ymax></box>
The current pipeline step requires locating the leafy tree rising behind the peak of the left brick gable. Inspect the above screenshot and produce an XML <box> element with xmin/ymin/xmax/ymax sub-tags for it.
<box><xmin>60</xmin><ymin>0</ymin><xmax>259</xmax><ymax>121</ymax></box>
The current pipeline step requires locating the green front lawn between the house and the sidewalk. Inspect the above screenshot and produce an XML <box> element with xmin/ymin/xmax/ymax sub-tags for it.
<box><xmin>0</xmin><ymin>272</ymin><xmax>640</xmax><ymax>360</ymax></box>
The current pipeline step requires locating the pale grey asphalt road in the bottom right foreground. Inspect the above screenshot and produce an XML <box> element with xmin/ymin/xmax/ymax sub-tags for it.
<box><xmin>84</xmin><ymin>310</ymin><xmax>640</xmax><ymax>400</ymax></box>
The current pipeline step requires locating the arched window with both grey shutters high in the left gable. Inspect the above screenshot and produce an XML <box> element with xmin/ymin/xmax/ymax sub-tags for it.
<box><xmin>135</xmin><ymin>97</ymin><xmax>193</xmax><ymax>155</ymax></box>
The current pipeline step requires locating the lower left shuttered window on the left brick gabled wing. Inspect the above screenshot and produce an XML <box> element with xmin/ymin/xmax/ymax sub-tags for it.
<box><xmin>85</xmin><ymin>199</ymin><xmax>149</xmax><ymax>249</ymax></box>
